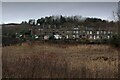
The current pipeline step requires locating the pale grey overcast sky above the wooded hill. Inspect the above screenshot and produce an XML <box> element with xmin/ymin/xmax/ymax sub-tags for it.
<box><xmin>2</xmin><ymin>2</ymin><xmax>118</xmax><ymax>23</ymax></box>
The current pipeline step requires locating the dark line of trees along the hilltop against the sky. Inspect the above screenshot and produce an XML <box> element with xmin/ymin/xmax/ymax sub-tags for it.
<box><xmin>25</xmin><ymin>15</ymin><xmax>115</xmax><ymax>27</ymax></box>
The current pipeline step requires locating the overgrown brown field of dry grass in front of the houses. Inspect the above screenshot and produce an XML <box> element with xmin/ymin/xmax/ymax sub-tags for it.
<box><xmin>2</xmin><ymin>43</ymin><xmax>118</xmax><ymax>78</ymax></box>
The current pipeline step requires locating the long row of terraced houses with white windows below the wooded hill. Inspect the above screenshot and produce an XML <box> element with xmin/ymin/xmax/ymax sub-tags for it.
<box><xmin>31</xmin><ymin>25</ymin><xmax>117</xmax><ymax>41</ymax></box>
